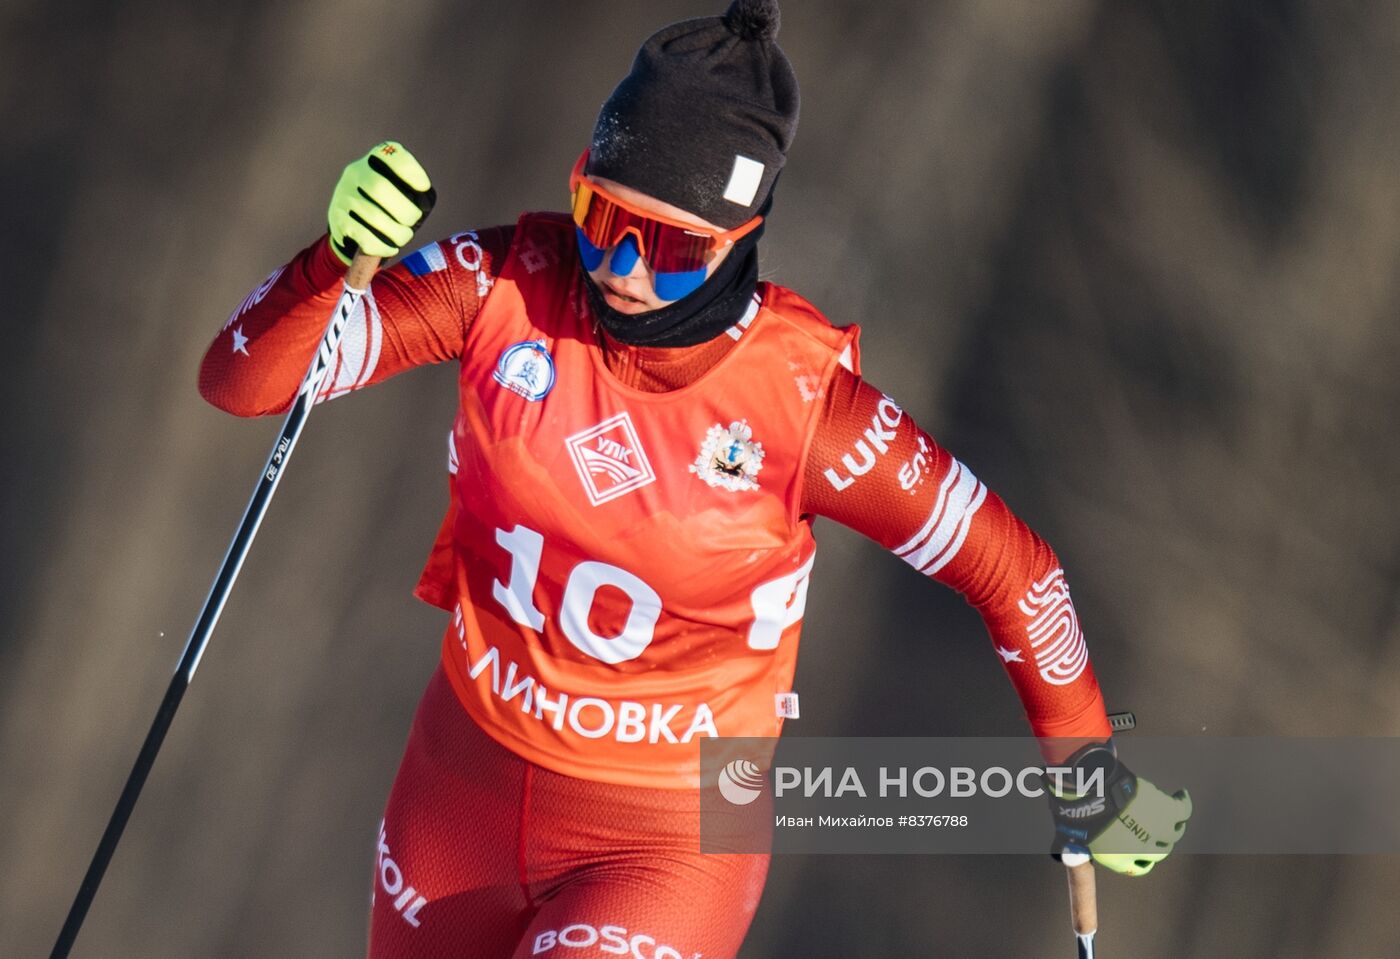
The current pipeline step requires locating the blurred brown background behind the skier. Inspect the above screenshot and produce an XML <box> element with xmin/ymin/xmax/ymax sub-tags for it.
<box><xmin>0</xmin><ymin>0</ymin><xmax>1400</xmax><ymax>959</ymax></box>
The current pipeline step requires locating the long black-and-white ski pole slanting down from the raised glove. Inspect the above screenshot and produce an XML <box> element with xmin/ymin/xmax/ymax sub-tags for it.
<box><xmin>49</xmin><ymin>253</ymin><xmax>379</xmax><ymax>959</ymax></box>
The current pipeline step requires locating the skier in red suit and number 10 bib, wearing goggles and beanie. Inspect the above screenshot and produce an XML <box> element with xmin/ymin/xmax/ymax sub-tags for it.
<box><xmin>200</xmin><ymin>0</ymin><xmax>1190</xmax><ymax>959</ymax></box>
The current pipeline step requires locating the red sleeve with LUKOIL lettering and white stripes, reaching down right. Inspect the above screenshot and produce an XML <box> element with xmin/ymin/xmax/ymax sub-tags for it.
<box><xmin>802</xmin><ymin>368</ymin><xmax>1110</xmax><ymax>759</ymax></box>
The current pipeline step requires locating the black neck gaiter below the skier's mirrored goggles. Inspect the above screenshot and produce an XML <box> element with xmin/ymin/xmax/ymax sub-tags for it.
<box><xmin>578</xmin><ymin>223</ymin><xmax>766</xmax><ymax>346</ymax></box>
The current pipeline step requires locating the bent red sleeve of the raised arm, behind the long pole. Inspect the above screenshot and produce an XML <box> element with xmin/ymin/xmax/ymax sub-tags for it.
<box><xmin>199</xmin><ymin>227</ymin><xmax>514</xmax><ymax>416</ymax></box>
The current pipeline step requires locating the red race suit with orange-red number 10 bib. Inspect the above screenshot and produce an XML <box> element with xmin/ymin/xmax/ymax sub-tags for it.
<box><xmin>200</xmin><ymin>214</ymin><xmax>1109</xmax><ymax>959</ymax></box>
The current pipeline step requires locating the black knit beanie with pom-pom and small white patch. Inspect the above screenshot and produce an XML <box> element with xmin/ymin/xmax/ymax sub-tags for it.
<box><xmin>588</xmin><ymin>0</ymin><xmax>798</xmax><ymax>230</ymax></box>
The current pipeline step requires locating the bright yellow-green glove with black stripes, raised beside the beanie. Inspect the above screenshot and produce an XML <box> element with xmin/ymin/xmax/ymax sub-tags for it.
<box><xmin>326</xmin><ymin>140</ymin><xmax>437</xmax><ymax>263</ymax></box>
